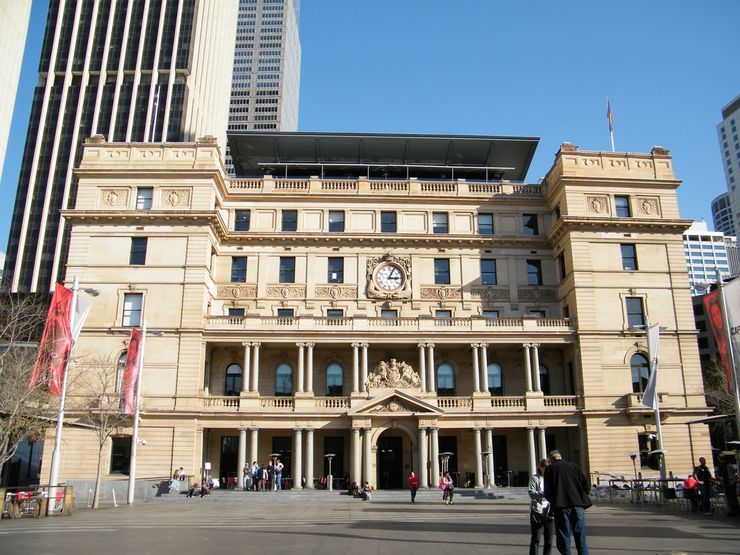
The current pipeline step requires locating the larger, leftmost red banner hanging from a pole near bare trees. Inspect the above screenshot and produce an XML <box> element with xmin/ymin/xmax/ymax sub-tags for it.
<box><xmin>28</xmin><ymin>284</ymin><xmax>73</xmax><ymax>395</ymax></box>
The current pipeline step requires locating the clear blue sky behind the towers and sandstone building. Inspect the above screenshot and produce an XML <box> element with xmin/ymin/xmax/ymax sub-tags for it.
<box><xmin>0</xmin><ymin>0</ymin><xmax>740</xmax><ymax>254</ymax></box>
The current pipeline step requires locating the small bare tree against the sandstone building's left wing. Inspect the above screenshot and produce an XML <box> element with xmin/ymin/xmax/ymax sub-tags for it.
<box><xmin>68</xmin><ymin>355</ymin><xmax>131</xmax><ymax>509</ymax></box>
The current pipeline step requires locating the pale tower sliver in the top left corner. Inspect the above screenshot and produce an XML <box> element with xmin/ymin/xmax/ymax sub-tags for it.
<box><xmin>0</xmin><ymin>0</ymin><xmax>31</xmax><ymax>176</ymax></box>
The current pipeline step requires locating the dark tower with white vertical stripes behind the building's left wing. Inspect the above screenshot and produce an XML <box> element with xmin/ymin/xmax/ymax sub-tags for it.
<box><xmin>5</xmin><ymin>0</ymin><xmax>238</xmax><ymax>292</ymax></box>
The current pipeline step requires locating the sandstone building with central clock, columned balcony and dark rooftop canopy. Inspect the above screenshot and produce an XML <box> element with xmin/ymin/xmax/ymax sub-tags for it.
<box><xmin>44</xmin><ymin>133</ymin><xmax>710</xmax><ymax>488</ymax></box>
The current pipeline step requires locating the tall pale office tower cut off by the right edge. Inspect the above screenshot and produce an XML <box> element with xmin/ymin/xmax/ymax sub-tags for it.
<box><xmin>712</xmin><ymin>95</ymin><xmax>740</xmax><ymax>237</ymax></box>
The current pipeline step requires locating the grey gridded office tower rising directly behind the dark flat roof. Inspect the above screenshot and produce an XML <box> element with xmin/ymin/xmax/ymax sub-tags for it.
<box><xmin>226</xmin><ymin>0</ymin><xmax>301</xmax><ymax>175</ymax></box>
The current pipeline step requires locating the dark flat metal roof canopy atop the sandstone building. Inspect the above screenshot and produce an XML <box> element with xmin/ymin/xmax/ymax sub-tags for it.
<box><xmin>229</xmin><ymin>131</ymin><xmax>539</xmax><ymax>181</ymax></box>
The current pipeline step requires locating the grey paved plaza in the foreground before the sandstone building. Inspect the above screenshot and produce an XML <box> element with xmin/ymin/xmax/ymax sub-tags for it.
<box><xmin>0</xmin><ymin>492</ymin><xmax>740</xmax><ymax>555</ymax></box>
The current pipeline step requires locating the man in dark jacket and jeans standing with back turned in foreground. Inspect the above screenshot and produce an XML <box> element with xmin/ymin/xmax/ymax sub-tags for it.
<box><xmin>545</xmin><ymin>450</ymin><xmax>592</xmax><ymax>555</ymax></box>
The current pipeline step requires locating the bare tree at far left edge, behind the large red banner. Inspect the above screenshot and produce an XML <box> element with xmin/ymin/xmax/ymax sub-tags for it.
<box><xmin>0</xmin><ymin>289</ymin><xmax>55</xmax><ymax>480</ymax></box>
